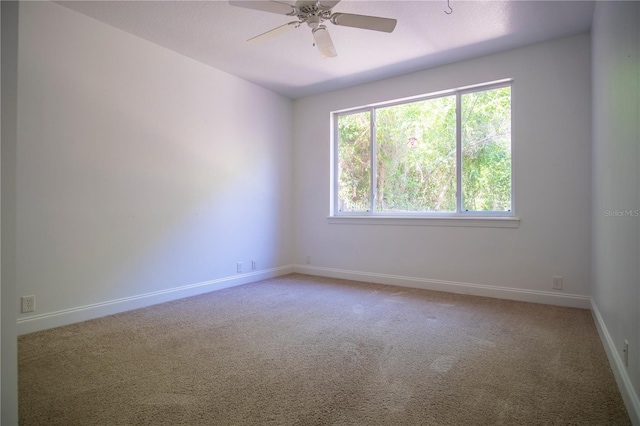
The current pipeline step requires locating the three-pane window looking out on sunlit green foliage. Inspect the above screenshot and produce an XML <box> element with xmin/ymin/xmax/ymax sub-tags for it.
<box><xmin>333</xmin><ymin>82</ymin><xmax>512</xmax><ymax>216</ymax></box>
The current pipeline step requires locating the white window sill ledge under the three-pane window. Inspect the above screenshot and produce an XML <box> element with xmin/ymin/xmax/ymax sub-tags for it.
<box><xmin>327</xmin><ymin>215</ymin><xmax>520</xmax><ymax>228</ymax></box>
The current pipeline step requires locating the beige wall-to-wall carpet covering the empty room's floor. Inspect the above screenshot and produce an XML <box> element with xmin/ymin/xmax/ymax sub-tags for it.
<box><xmin>19</xmin><ymin>275</ymin><xmax>630</xmax><ymax>425</ymax></box>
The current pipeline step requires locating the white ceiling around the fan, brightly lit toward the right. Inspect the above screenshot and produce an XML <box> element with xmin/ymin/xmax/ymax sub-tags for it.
<box><xmin>57</xmin><ymin>0</ymin><xmax>594</xmax><ymax>99</ymax></box>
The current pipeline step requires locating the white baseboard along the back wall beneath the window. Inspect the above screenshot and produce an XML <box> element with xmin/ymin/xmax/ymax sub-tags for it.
<box><xmin>294</xmin><ymin>265</ymin><xmax>591</xmax><ymax>309</ymax></box>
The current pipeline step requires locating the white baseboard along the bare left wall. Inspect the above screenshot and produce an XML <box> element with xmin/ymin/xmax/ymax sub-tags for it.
<box><xmin>17</xmin><ymin>266</ymin><xmax>294</xmax><ymax>335</ymax></box>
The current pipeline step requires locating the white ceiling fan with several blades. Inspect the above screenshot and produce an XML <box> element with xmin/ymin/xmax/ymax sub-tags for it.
<box><xmin>229</xmin><ymin>0</ymin><xmax>397</xmax><ymax>58</ymax></box>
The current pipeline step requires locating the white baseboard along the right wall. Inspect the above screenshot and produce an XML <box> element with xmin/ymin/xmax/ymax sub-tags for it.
<box><xmin>591</xmin><ymin>300</ymin><xmax>640</xmax><ymax>426</ymax></box>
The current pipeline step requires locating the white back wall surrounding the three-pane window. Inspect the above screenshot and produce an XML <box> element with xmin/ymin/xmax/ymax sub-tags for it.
<box><xmin>294</xmin><ymin>34</ymin><xmax>591</xmax><ymax>305</ymax></box>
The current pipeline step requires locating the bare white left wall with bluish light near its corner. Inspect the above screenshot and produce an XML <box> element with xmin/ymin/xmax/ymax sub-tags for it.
<box><xmin>17</xmin><ymin>2</ymin><xmax>292</xmax><ymax>332</ymax></box>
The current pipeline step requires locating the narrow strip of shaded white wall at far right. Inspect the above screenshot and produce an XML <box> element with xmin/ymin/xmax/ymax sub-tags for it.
<box><xmin>592</xmin><ymin>2</ymin><xmax>640</xmax><ymax>424</ymax></box>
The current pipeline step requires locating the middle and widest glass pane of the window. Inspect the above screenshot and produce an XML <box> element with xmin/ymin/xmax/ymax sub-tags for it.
<box><xmin>376</xmin><ymin>96</ymin><xmax>456</xmax><ymax>213</ymax></box>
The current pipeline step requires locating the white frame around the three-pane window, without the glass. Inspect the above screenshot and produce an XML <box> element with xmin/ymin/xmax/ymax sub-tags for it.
<box><xmin>328</xmin><ymin>78</ymin><xmax>520</xmax><ymax>227</ymax></box>
